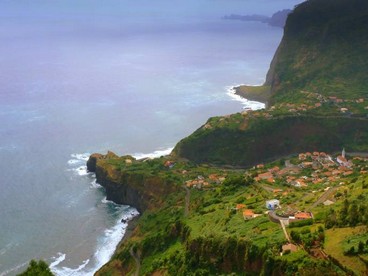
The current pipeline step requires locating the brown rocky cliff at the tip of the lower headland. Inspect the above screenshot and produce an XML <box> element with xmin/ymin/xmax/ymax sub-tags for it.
<box><xmin>87</xmin><ymin>152</ymin><xmax>180</xmax><ymax>212</ymax></box>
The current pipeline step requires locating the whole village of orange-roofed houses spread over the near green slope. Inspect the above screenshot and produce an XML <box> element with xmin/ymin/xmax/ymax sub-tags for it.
<box><xmin>171</xmin><ymin>149</ymin><xmax>368</xmax><ymax>236</ymax></box>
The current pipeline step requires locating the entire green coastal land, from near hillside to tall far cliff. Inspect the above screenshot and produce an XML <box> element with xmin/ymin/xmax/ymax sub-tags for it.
<box><xmin>87</xmin><ymin>0</ymin><xmax>368</xmax><ymax>275</ymax></box>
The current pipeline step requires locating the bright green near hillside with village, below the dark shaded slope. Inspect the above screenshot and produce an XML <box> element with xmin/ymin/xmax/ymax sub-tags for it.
<box><xmin>97</xmin><ymin>152</ymin><xmax>368</xmax><ymax>275</ymax></box>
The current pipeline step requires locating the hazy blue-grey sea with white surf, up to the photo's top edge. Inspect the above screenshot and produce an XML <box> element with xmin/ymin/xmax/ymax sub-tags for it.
<box><xmin>0</xmin><ymin>0</ymin><xmax>300</xmax><ymax>276</ymax></box>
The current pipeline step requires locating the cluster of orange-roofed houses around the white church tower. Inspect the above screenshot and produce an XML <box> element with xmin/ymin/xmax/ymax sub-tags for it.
<box><xmin>254</xmin><ymin>150</ymin><xmax>365</xmax><ymax>187</ymax></box>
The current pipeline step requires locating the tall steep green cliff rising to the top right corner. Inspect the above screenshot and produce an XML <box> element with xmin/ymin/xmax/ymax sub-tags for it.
<box><xmin>266</xmin><ymin>0</ymin><xmax>368</xmax><ymax>103</ymax></box>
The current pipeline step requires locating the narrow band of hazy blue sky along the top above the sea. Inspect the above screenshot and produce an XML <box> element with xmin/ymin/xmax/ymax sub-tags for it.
<box><xmin>0</xmin><ymin>0</ymin><xmax>303</xmax><ymax>17</ymax></box>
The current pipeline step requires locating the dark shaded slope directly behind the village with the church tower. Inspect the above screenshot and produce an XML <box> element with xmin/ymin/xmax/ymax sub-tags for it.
<box><xmin>174</xmin><ymin>116</ymin><xmax>368</xmax><ymax>167</ymax></box>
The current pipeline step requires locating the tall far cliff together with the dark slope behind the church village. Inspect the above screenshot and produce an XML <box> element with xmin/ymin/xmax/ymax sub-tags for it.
<box><xmin>174</xmin><ymin>0</ymin><xmax>368</xmax><ymax>166</ymax></box>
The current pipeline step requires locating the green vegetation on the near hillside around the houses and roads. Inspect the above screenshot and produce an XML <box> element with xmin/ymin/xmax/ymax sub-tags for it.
<box><xmin>99</xmin><ymin>152</ymin><xmax>368</xmax><ymax>275</ymax></box>
